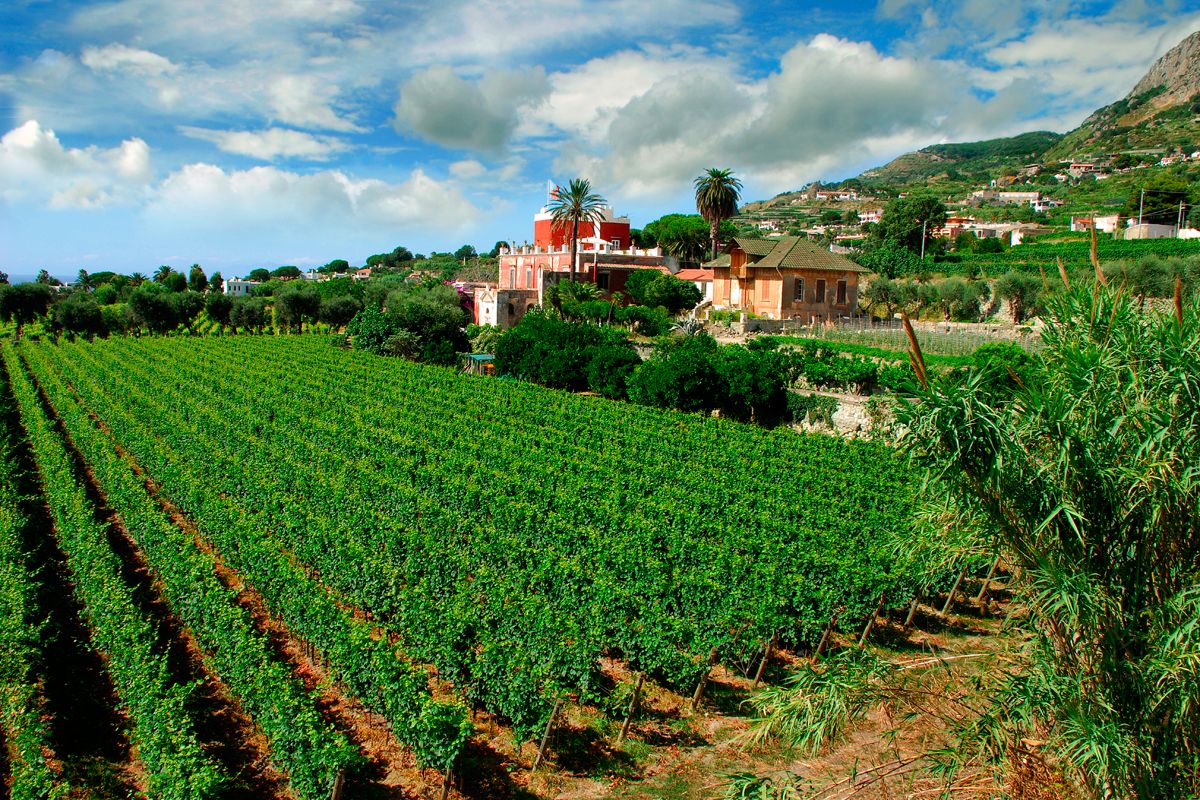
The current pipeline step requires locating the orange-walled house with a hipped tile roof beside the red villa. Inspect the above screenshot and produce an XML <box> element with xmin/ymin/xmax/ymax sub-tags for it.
<box><xmin>712</xmin><ymin>236</ymin><xmax>866</xmax><ymax>323</ymax></box>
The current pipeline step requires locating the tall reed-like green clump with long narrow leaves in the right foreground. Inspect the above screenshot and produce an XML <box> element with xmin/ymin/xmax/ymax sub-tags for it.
<box><xmin>901</xmin><ymin>284</ymin><xmax>1200</xmax><ymax>800</ymax></box>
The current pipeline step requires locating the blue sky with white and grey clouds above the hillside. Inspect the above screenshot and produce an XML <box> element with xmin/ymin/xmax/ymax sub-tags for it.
<box><xmin>0</xmin><ymin>0</ymin><xmax>1200</xmax><ymax>277</ymax></box>
